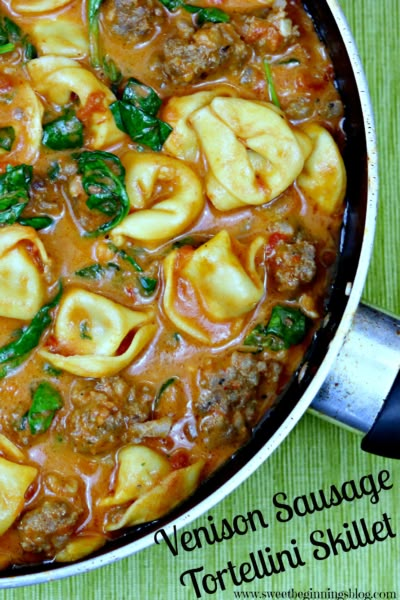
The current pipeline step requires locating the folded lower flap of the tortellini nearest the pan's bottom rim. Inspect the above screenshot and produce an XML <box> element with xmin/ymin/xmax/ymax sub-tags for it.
<box><xmin>106</xmin><ymin>460</ymin><xmax>204</xmax><ymax>531</ymax></box>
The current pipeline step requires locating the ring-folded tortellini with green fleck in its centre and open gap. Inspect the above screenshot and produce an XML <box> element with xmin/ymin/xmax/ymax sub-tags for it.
<box><xmin>39</xmin><ymin>288</ymin><xmax>156</xmax><ymax>377</ymax></box>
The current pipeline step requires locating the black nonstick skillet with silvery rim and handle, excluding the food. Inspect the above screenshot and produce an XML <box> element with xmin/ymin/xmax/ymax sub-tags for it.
<box><xmin>0</xmin><ymin>0</ymin><xmax>400</xmax><ymax>588</ymax></box>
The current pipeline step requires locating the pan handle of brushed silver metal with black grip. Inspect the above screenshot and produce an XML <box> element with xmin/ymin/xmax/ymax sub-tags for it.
<box><xmin>311</xmin><ymin>305</ymin><xmax>400</xmax><ymax>458</ymax></box>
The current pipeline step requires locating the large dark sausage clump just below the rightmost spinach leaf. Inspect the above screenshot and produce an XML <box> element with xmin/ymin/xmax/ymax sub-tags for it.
<box><xmin>194</xmin><ymin>352</ymin><xmax>282</xmax><ymax>447</ymax></box>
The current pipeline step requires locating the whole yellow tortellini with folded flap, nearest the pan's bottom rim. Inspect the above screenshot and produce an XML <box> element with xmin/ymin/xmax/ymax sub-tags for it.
<box><xmin>102</xmin><ymin>446</ymin><xmax>204</xmax><ymax>531</ymax></box>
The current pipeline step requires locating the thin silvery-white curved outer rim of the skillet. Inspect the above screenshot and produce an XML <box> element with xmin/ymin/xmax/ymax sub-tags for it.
<box><xmin>0</xmin><ymin>0</ymin><xmax>378</xmax><ymax>589</ymax></box>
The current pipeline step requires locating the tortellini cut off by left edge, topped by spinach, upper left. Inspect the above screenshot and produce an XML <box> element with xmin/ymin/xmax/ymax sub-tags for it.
<box><xmin>0</xmin><ymin>81</ymin><xmax>43</xmax><ymax>165</ymax></box>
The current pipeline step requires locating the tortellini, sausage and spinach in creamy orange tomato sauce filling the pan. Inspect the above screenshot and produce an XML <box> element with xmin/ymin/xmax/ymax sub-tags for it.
<box><xmin>0</xmin><ymin>0</ymin><xmax>346</xmax><ymax>568</ymax></box>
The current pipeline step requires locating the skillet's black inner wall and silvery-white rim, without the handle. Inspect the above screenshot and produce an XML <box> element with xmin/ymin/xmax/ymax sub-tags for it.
<box><xmin>0</xmin><ymin>0</ymin><xmax>396</xmax><ymax>587</ymax></box>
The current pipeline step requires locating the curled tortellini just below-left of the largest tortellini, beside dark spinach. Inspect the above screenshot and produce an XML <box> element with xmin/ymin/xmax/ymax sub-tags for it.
<box><xmin>111</xmin><ymin>152</ymin><xmax>204</xmax><ymax>244</ymax></box>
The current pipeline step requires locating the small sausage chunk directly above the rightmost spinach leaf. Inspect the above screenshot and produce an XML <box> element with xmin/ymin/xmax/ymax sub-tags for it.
<box><xmin>268</xmin><ymin>240</ymin><xmax>317</xmax><ymax>291</ymax></box>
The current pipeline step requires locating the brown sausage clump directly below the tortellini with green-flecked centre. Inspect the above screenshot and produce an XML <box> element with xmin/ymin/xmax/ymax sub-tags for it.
<box><xmin>66</xmin><ymin>376</ymin><xmax>154</xmax><ymax>454</ymax></box>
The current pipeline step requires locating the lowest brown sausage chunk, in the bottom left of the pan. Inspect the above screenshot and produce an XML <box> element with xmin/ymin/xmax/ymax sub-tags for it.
<box><xmin>18</xmin><ymin>499</ymin><xmax>82</xmax><ymax>556</ymax></box>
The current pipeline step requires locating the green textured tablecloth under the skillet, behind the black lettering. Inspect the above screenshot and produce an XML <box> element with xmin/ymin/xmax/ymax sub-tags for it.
<box><xmin>0</xmin><ymin>0</ymin><xmax>400</xmax><ymax>600</ymax></box>
